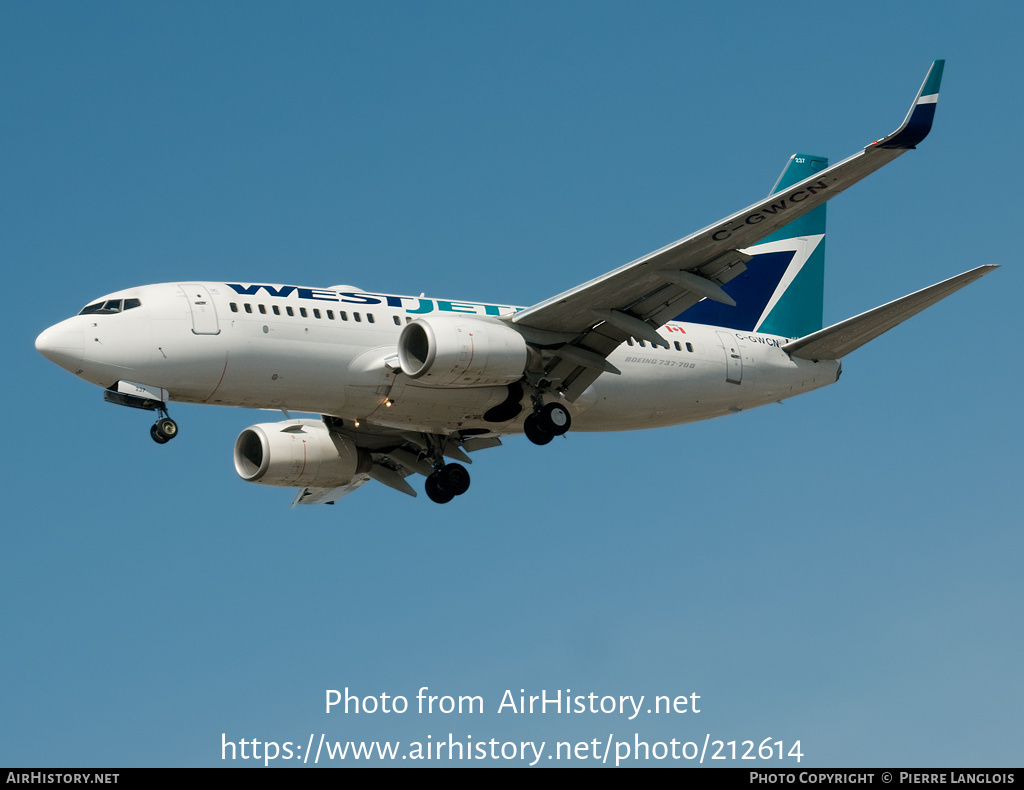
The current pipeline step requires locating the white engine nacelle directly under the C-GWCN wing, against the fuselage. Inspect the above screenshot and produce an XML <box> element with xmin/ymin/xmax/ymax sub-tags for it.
<box><xmin>398</xmin><ymin>316</ymin><xmax>530</xmax><ymax>387</ymax></box>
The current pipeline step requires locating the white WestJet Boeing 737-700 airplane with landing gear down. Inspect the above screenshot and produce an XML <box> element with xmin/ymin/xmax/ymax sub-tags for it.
<box><xmin>36</xmin><ymin>60</ymin><xmax>997</xmax><ymax>506</ymax></box>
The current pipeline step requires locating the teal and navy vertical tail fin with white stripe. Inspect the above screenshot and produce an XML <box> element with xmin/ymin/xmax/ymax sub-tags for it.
<box><xmin>676</xmin><ymin>154</ymin><xmax>828</xmax><ymax>337</ymax></box>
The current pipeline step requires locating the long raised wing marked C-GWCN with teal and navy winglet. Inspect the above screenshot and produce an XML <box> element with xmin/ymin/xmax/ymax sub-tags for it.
<box><xmin>511</xmin><ymin>60</ymin><xmax>945</xmax><ymax>401</ymax></box>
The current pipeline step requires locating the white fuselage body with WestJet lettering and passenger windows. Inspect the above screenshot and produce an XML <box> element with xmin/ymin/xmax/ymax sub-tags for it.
<box><xmin>37</xmin><ymin>283</ymin><xmax>840</xmax><ymax>434</ymax></box>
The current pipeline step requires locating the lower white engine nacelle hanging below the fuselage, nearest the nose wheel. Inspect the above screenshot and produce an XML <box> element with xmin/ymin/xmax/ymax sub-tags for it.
<box><xmin>234</xmin><ymin>420</ymin><xmax>373</xmax><ymax>488</ymax></box>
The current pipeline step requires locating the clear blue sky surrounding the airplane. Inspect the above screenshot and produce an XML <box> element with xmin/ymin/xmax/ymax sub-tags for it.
<box><xmin>0</xmin><ymin>2</ymin><xmax>1024</xmax><ymax>766</ymax></box>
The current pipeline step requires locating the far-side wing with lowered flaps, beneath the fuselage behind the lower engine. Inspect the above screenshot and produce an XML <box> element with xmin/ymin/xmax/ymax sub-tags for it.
<box><xmin>292</xmin><ymin>415</ymin><xmax>502</xmax><ymax>507</ymax></box>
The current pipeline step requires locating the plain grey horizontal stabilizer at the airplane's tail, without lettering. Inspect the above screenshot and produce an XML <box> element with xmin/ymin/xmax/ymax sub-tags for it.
<box><xmin>782</xmin><ymin>264</ymin><xmax>998</xmax><ymax>360</ymax></box>
